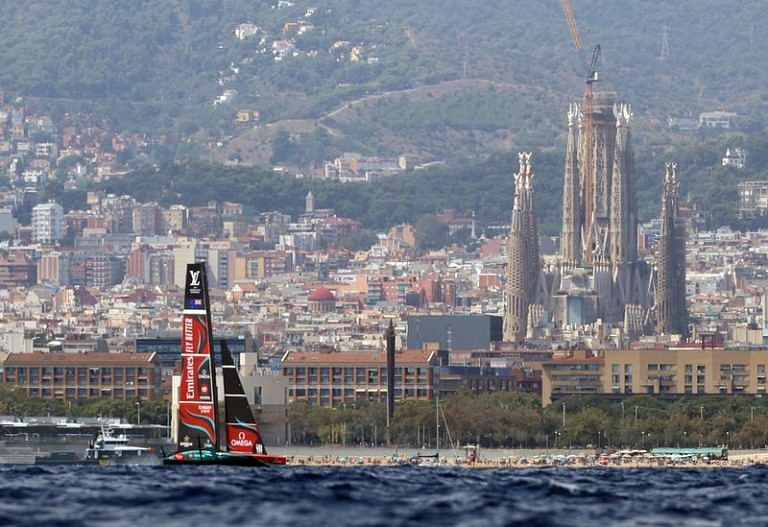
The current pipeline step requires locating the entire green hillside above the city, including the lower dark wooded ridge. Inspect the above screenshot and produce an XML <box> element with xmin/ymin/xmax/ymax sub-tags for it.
<box><xmin>9</xmin><ymin>0</ymin><xmax>768</xmax><ymax>233</ymax></box>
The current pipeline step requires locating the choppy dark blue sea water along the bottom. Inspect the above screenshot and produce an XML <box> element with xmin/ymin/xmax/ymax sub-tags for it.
<box><xmin>0</xmin><ymin>466</ymin><xmax>768</xmax><ymax>527</ymax></box>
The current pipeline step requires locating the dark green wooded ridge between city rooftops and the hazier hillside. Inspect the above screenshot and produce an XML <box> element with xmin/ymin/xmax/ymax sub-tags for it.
<box><xmin>91</xmin><ymin>134</ymin><xmax>768</xmax><ymax>235</ymax></box>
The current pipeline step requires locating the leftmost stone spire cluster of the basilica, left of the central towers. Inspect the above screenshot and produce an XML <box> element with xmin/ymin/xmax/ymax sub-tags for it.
<box><xmin>504</xmin><ymin>153</ymin><xmax>540</xmax><ymax>342</ymax></box>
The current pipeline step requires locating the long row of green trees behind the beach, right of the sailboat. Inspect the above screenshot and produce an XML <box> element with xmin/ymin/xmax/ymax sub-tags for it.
<box><xmin>289</xmin><ymin>392</ymin><xmax>768</xmax><ymax>448</ymax></box>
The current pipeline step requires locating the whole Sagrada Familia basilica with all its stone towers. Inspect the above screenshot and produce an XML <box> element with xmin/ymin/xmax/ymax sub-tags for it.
<box><xmin>504</xmin><ymin>92</ymin><xmax>688</xmax><ymax>343</ymax></box>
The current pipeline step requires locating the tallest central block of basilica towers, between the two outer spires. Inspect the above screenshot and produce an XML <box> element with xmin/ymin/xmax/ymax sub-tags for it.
<box><xmin>543</xmin><ymin>92</ymin><xmax>650</xmax><ymax>327</ymax></box>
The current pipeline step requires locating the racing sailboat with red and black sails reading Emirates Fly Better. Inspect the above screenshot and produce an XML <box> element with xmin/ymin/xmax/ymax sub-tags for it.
<box><xmin>163</xmin><ymin>263</ymin><xmax>285</xmax><ymax>467</ymax></box>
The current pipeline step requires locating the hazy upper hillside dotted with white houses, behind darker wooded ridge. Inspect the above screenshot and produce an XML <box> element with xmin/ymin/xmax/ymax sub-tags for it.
<box><xmin>0</xmin><ymin>0</ymin><xmax>768</xmax><ymax>163</ymax></box>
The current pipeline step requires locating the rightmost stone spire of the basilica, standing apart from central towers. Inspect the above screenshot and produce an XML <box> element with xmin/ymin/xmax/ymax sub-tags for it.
<box><xmin>656</xmin><ymin>163</ymin><xmax>688</xmax><ymax>336</ymax></box>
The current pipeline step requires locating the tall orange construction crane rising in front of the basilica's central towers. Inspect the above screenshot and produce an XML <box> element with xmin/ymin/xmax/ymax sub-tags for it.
<box><xmin>560</xmin><ymin>0</ymin><xmax>600</xmax><ymax>264</ymax></box>
